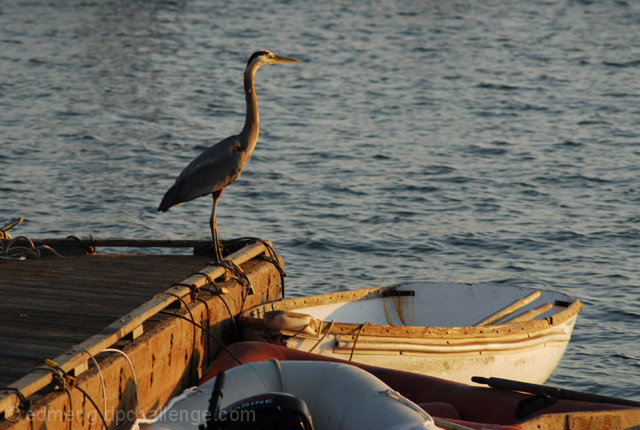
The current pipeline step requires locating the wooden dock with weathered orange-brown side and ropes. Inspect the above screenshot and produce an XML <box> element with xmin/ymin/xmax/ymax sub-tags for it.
<box><xmin>0</xmin><ymin>239</ymin><xmax>283</xmax><ymax>430</ymax></box>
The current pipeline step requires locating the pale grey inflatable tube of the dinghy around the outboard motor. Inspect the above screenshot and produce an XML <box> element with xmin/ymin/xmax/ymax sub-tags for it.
<box><xmin>140</xmin><ymin>359</ymin><xmax>439</xmax><ymax>430</ymax></box>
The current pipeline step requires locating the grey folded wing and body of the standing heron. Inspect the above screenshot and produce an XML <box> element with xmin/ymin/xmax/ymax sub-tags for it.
<box><xmin>158</xmin><ymin>136</ymin><xmax>246</xmax><ymax>211</ymax></box>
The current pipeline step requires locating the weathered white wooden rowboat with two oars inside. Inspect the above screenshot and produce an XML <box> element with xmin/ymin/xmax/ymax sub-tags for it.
<box><xmin>239</xmin><ymin>282</ymin><xmax>582</xmax><ymax>384</ymax></box>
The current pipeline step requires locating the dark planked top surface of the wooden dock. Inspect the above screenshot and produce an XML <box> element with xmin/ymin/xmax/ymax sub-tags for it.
<box><xmin>0</xmin><ymin>255</ymin><xmax>215</xmax><ymax>386</ymax></box>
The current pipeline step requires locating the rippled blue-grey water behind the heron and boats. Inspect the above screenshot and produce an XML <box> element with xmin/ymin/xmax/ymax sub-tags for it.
<box><xmin>0</xmin><ymin>0</ymin><xmax>640</xmax><ymax>399</ymax></box>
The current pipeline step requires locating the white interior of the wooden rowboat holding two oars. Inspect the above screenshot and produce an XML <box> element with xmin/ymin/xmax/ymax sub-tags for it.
<box><xmin>282</xmin><ymin>283</ymin><xmax>575</xmax><ymax>327</ymax></box>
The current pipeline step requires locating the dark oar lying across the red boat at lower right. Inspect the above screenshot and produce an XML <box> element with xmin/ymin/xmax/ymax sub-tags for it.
<box><xmin>471</xmin><ymin>376</ymin><xmax>640</xmax><ymax>407</ymax></box>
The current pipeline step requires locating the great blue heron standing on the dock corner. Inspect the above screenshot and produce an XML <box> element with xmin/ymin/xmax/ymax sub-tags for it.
<box><xmin>158</xmin><ymin>50</ymin><xmax>299</xmax><ymax>263</ymax></box>
